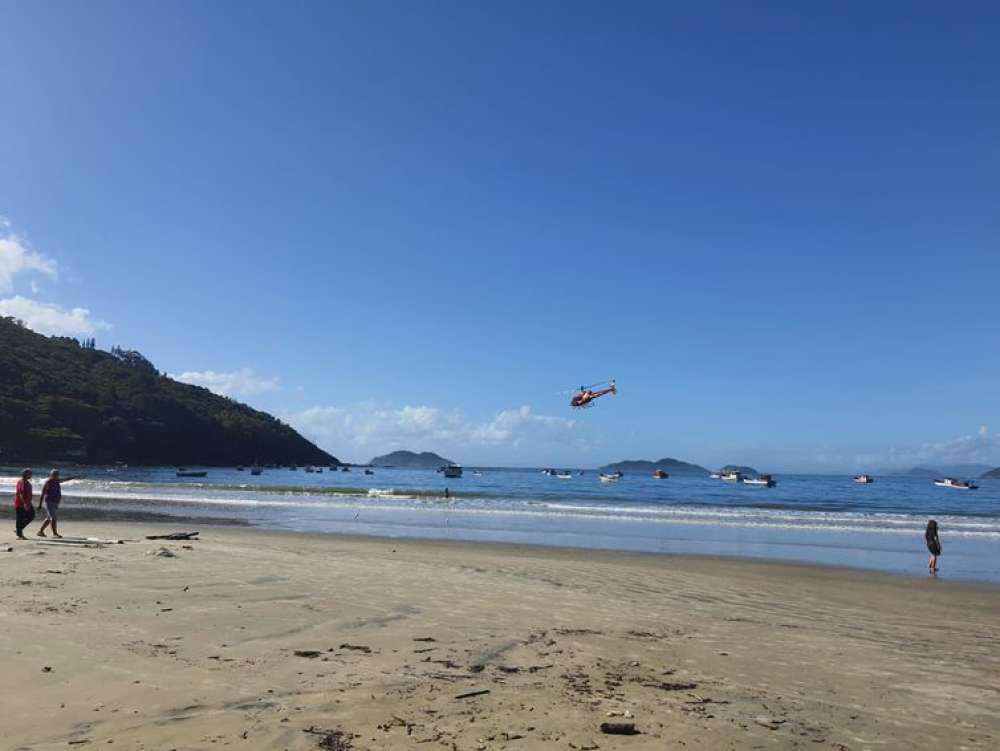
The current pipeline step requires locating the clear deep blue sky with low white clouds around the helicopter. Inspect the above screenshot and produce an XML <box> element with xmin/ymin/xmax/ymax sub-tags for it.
<box><xmin>0</xmin><ymin>2</ymin><xmax>1000</xmax><ymax>471</ymax></box>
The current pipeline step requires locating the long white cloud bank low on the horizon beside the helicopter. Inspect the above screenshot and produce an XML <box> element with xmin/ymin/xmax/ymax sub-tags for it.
<box><xmin>285</xmin><ymin>402</ymin><xmax>583</xmax><ymax>462</ymax></box>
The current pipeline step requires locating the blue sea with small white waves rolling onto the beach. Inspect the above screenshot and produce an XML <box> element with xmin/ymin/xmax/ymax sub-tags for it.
<box><xmin>0</xmin><ymin>468</ymin><xmax>1000</xmax><ymax>582</ymax></box>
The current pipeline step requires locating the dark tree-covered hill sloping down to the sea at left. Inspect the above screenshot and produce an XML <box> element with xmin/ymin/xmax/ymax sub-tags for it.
<box><xmin>0</xmin><ymin>318</ymin><xmax>337</xmax><ymax>466</ymax></box>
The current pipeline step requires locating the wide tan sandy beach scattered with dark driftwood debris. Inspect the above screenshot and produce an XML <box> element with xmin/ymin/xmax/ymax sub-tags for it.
<box><xmin>0</xmin><ymin>519</ymin><xmax>1000</xmax><ymax>751</ymax></box>
